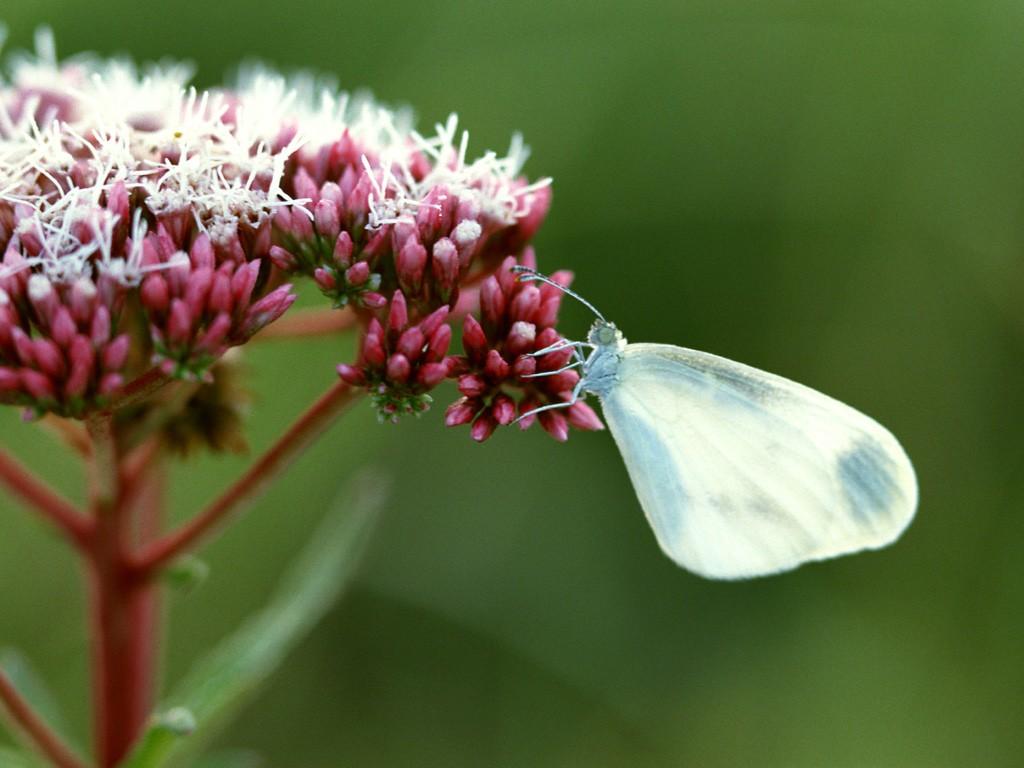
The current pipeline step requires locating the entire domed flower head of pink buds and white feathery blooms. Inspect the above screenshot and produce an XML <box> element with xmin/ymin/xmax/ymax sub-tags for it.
<box><xmin>0</xmin><ymin>33</ymin><xmax>599</xmax><ymax>439</ymax></box>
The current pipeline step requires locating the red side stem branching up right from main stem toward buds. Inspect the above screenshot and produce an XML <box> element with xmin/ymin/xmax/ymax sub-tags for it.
<box><xmin>134</xmin><ymin>382</ymin><xmax>361</xmax><ymax>578</ymax></box>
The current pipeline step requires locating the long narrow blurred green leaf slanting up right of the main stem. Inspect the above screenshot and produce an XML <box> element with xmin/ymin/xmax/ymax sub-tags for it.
<box><xmin>161</xmin><ymin>473</ymin><xmax>386</xmax><ymax>765</ymax></box>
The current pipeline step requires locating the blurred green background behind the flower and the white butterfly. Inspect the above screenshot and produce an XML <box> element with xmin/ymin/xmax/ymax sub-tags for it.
<box><xmin>0</xmin><ymin>0</ymin><xmax>1024</xmax><ymax>768</ymax></box>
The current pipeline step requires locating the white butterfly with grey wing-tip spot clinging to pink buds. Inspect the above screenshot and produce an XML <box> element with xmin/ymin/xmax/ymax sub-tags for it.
<box><xmin>516</xmin><ymin>268</ymin><xmax>918</xmax><ymax>579</ymax></box>
